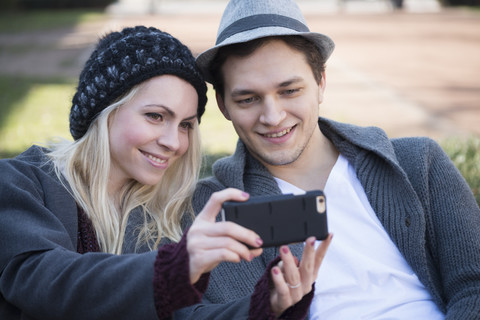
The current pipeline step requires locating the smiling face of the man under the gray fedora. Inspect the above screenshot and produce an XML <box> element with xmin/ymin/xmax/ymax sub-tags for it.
<box><xmin>217</xmin><ymin>40</ymin><xmax>325</xmax><ymax>167</ymax></box>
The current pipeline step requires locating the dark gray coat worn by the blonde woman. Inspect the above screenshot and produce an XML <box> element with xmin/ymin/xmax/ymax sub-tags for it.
<box><xmin>0</xmin><ymin>147</ymin><xmax>198</xmax><ymax>320</ymax></box>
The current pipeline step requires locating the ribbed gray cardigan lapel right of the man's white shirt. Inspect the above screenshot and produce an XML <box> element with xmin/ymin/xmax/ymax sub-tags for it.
<box><xmin>319</xmin><ymin>118</ymin><xmax>431</xmax><ymax>292</ymax></box>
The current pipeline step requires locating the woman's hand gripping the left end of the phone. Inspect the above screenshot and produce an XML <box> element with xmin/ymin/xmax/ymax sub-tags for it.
<box><xmin>187</xmin><ymin>188</ymin><xmax>263</xmax><ymax>284</ymax></box>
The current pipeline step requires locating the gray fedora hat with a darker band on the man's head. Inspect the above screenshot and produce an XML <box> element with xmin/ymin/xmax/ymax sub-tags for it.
<box><xmin>197</xmin><ymin>0</ymin><xmax>335</xmax><ymax>82</ymax></box>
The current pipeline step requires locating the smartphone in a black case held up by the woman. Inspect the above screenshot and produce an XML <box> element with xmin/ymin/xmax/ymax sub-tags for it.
<box><xmin>221</xmin><ymin>190</ymin><xmax>328</xmax><ymax>247</ymax></box>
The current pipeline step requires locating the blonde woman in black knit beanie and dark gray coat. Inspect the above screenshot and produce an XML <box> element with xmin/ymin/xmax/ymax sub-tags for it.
<box><xmin>0</xmin><ymin>27</ymin><xmax>262</xmax><ymax>319</ymax></box>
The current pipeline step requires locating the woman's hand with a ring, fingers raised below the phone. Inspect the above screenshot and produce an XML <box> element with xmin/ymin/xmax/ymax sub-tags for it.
<box><xmin>270</xmin><ymin>234</ymin><xmax>333</xmax><ymax>316</ymax></box>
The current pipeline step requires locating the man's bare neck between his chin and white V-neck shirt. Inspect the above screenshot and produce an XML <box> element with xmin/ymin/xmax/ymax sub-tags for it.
<box><xmin>266</xmin><ymin>133</ymin><xmax>339</xmax><ymax>191</ymax></box>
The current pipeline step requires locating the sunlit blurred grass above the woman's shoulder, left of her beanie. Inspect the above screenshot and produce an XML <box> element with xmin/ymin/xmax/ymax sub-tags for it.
<box><xmin>0</xmin><ymin>76</ymin><xmax>74</xmax><ymax>157</ymax></box>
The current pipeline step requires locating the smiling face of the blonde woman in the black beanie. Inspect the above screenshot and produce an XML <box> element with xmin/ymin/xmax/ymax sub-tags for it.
<box><xmin>109</xmin><ymin>75</ymin><xmax>198</xmax><ymax>192</ymax></box>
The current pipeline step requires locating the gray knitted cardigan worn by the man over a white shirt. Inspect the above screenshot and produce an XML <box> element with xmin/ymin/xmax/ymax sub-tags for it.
<box><xmin>177</xmin><ymin>118</ymin><xmax>480</xmax><ymax>319</ymax></box>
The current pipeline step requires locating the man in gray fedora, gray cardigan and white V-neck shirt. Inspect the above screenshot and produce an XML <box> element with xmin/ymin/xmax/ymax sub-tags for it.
<box><xmin>175</xmin><ymin>0</ymin><xmax>480</xmax><ymax>319</ymax></box>
